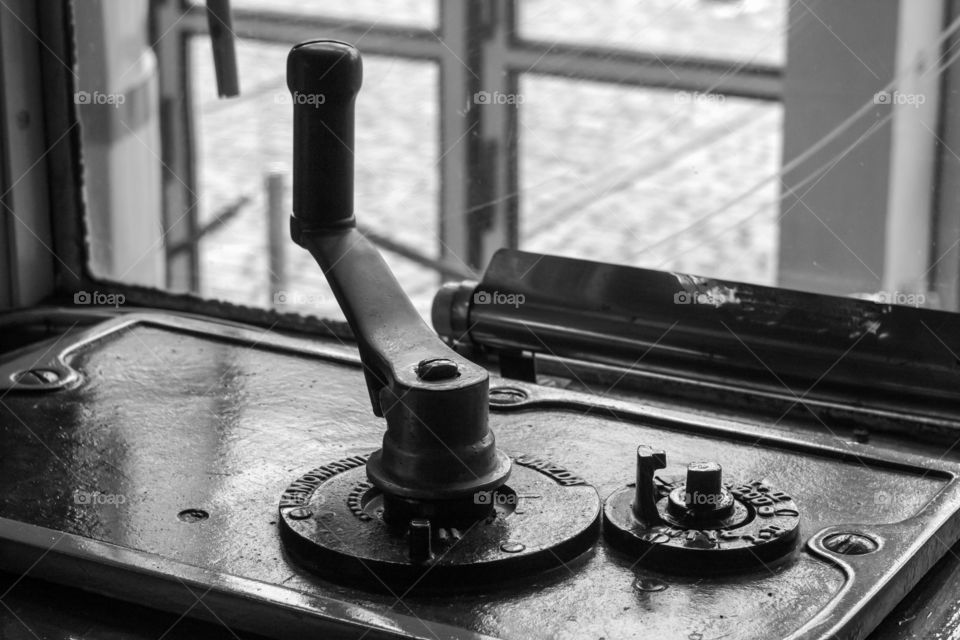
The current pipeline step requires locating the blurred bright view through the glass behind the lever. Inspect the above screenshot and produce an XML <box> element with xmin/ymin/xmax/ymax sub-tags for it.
<box><xmin>76</xmin><ymin>0</ymin><xmax>960</xmax><ymax>317</ymax></box>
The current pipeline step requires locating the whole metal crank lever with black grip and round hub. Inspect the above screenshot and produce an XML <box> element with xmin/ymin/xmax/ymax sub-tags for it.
<box><xmin>287</xmin><ymin>40</ymin><xmax>511</xmax><ymax>524</ymax></box>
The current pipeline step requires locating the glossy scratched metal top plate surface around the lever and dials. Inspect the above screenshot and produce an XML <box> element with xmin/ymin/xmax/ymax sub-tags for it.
<box><xmin>0</xmin><ymin>316</ymin><xmax>960</xmax><ymax>640</ymax></box>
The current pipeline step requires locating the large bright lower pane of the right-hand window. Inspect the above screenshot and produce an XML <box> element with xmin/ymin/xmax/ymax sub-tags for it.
<box><xmin>520</xmin><ymin>75</ymin><xmax>782</xmax><ymax>284</ymax></box>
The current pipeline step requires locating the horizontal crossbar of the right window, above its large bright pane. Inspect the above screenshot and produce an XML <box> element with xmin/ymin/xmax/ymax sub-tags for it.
<box><xmin>506</xmin><ymin>40</ymin><xmax>783</xmax><ymax>100</ymax></box>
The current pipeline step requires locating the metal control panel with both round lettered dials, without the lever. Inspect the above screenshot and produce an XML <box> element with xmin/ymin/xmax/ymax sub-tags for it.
<box><xmin>0</xmin><ymin>314</ymin><xmax>960</xmax><ymax>640</ymax></box>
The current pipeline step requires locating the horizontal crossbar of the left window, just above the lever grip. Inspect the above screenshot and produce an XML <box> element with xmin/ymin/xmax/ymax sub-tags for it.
<box><xmin>182</xmin><ymin>5</ymin><xmax>446</xmax><ymax>60</ymax></box>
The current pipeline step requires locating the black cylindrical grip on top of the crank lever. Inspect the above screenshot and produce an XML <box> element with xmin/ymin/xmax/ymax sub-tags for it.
<box><xmin>287</xmin><ymin>40</ymin><xmax>363</xmax><ymax>231</ymax></box>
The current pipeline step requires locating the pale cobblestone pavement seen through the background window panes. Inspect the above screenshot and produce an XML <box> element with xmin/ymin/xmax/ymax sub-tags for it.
<box><xmin>193</xmin><ymin>0</ymin><xmax>785</xmax><ymax>317</ymax></box>
